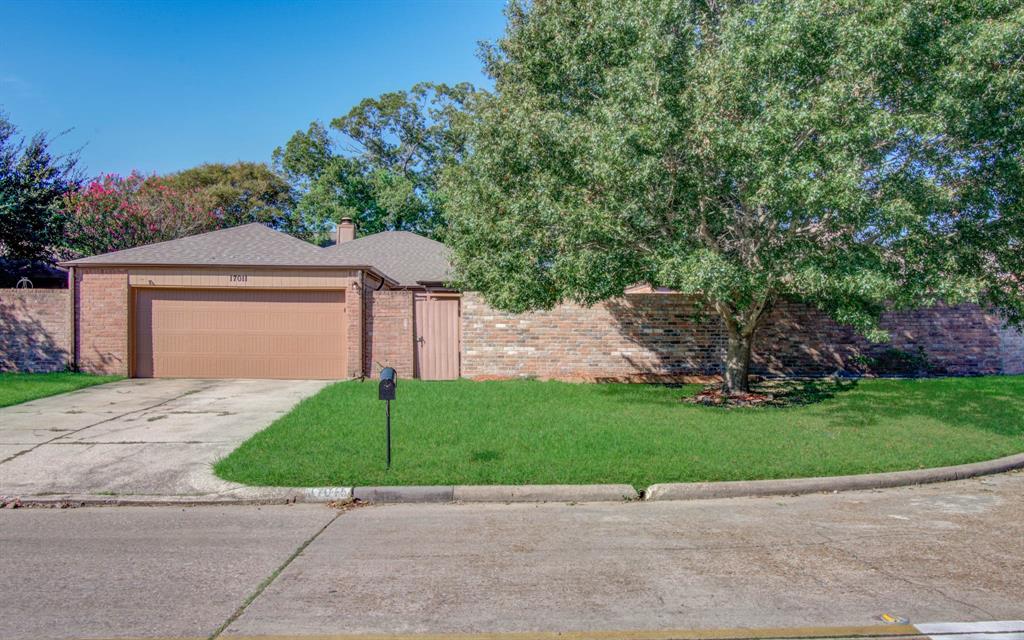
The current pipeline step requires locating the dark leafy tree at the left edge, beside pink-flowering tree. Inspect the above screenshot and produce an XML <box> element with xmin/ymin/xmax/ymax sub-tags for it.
<box><xmin>0</xmin><ymin>113</ymin><xmax>81</xmax><ymax>259</ymax></box>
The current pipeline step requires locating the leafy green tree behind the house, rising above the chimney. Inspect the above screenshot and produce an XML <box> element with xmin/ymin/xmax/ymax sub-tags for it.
<box><xmin>274</xmin><ymin>83</ymin><xmax>476</xmax><ymax>239</ymax></box>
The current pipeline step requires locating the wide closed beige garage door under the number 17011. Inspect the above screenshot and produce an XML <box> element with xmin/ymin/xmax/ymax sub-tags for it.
<box><xmin>134</xmin><ymin>289</ymin><xmax>346</xmax><ymax>379</ymax></box>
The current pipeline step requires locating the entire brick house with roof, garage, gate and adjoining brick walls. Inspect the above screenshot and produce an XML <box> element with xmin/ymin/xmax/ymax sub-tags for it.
<box><xmin>0</xmin><ymin>220</ymin><xmax>1024</xmax><ymax>380</ymax></box>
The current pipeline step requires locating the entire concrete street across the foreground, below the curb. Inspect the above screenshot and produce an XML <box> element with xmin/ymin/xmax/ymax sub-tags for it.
<box><xmin>0</xmin><ymin>472</ymin><xmax>1024</xmax><ymax>640</ymax></box>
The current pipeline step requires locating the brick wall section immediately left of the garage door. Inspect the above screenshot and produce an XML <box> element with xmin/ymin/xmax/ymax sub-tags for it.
<box><xmin>75</xmin><ymin>269</ymin><xmax>128</xmax><ymax>376</ymax></box>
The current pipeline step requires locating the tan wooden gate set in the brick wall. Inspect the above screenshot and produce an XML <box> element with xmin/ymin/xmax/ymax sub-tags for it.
<box><xmin>415</xmin><ymin>293</ymin><xmax>461</xmax><ymax>380</ymax></box>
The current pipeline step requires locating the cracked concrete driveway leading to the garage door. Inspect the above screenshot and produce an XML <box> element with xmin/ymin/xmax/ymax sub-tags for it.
<box><xmin>0</xmin><ymin>380</ymin><xmax>328</xmax><ymax>497</ymax></box>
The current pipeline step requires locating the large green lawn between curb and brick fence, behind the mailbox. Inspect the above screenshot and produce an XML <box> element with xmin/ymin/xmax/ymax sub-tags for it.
<box><xmin>209</xmin><ymin>376</ymin><xmax>1024</xmax><ymax>488</ymax></box>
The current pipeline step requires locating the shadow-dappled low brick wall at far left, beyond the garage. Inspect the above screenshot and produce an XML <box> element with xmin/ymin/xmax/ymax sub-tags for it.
<box><xmin>0</xmin><ymin>289</ymin><xmax>71</xmax><ymax>373</ymax></box>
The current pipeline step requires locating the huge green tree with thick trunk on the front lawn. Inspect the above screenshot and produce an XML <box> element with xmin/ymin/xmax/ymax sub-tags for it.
<box><xmin>444</xmin><ymin>0</ymin><xmax>1024</xmax><ymax>393</ymax></box>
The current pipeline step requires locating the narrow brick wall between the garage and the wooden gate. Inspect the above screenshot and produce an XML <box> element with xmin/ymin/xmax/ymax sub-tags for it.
<box><xmin>362</xmin><ymin>289</ymin><xmax>415</xmax><ymax>378</ymax></box>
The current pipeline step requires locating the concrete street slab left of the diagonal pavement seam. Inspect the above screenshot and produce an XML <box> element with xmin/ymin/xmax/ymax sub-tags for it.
<box><xmin>0</xmin><ymin>507</ymin><xmax>335</xmax><ymax>640</ymax></box>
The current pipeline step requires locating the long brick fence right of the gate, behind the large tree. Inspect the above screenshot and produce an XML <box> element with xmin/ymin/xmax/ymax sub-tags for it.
<box><xmin>462</xmin><ymin>293</ymin><xmax>1024</xmax><ymax>379</ymax></box>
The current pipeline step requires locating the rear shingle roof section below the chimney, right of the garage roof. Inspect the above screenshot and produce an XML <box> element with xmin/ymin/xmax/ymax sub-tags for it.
<box><xmin>324</xmin><ymin>231</ymin><xmax>451</xmax><ymax>287</ymax></box>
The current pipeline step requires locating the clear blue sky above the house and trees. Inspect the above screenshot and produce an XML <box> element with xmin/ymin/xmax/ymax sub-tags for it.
<box><xmin>0</xmin><ymin>0</ymin><xmax>505</xmax><ymax>174</ymax></box>
